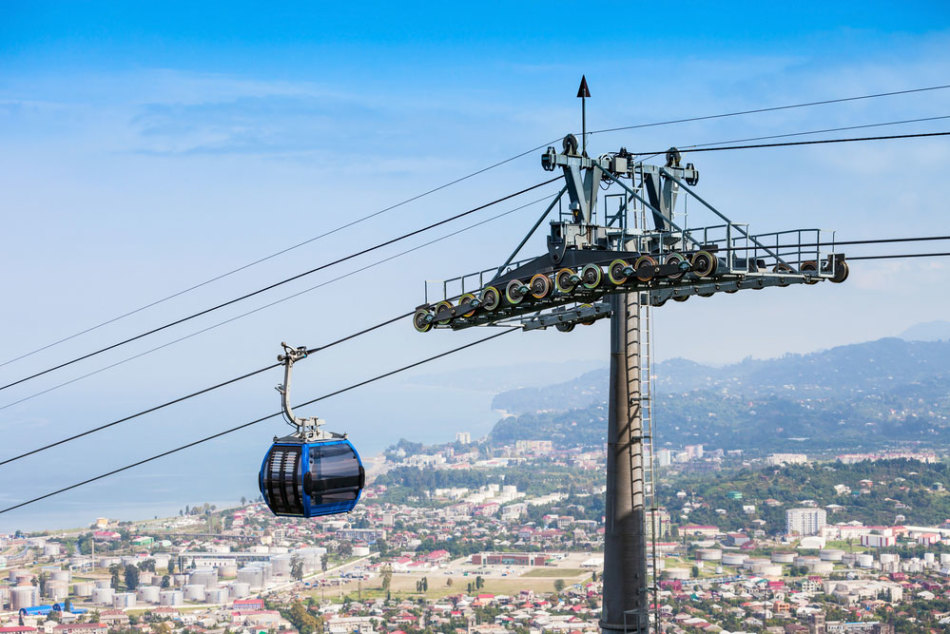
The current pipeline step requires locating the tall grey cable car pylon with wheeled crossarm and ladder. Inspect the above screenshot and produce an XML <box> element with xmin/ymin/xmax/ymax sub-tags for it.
<box><xmin>413</xmin><ymin>81</ymin><xmax>848</xmax><ymax>634</ymax></box>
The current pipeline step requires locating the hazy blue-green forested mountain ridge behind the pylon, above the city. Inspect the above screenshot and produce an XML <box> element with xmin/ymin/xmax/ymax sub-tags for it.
<box><xmin>491</xmin><ymin>338</ymin><xmax>950</xmax><ymax>451</ymax></box>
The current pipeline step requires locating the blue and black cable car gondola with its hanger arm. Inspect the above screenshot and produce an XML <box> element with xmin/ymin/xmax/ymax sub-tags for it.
<box><xmin>258</xmin><ymin>344</ymin><xmax>366</xmax><ymax>517</ymax></box>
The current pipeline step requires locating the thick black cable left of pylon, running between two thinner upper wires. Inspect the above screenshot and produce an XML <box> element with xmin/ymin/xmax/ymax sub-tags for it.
<box><xmin>0</xmin><ymin>177</ymin><xmax>560</xmax><ymax>391</ymax></box>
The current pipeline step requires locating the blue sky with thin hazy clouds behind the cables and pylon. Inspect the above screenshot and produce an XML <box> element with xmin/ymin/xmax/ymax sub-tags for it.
<box><xmin>0</xmin><ymin>2</ymin><xmax>950</xmax><ymax>528</ymax></box>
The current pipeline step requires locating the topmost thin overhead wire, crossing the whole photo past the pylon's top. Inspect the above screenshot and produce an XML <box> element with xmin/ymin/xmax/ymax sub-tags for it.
<box><xmin>9</xmin><ymin>84</ymin><xmax>950</xmax><ymax>367</ymax></box>
